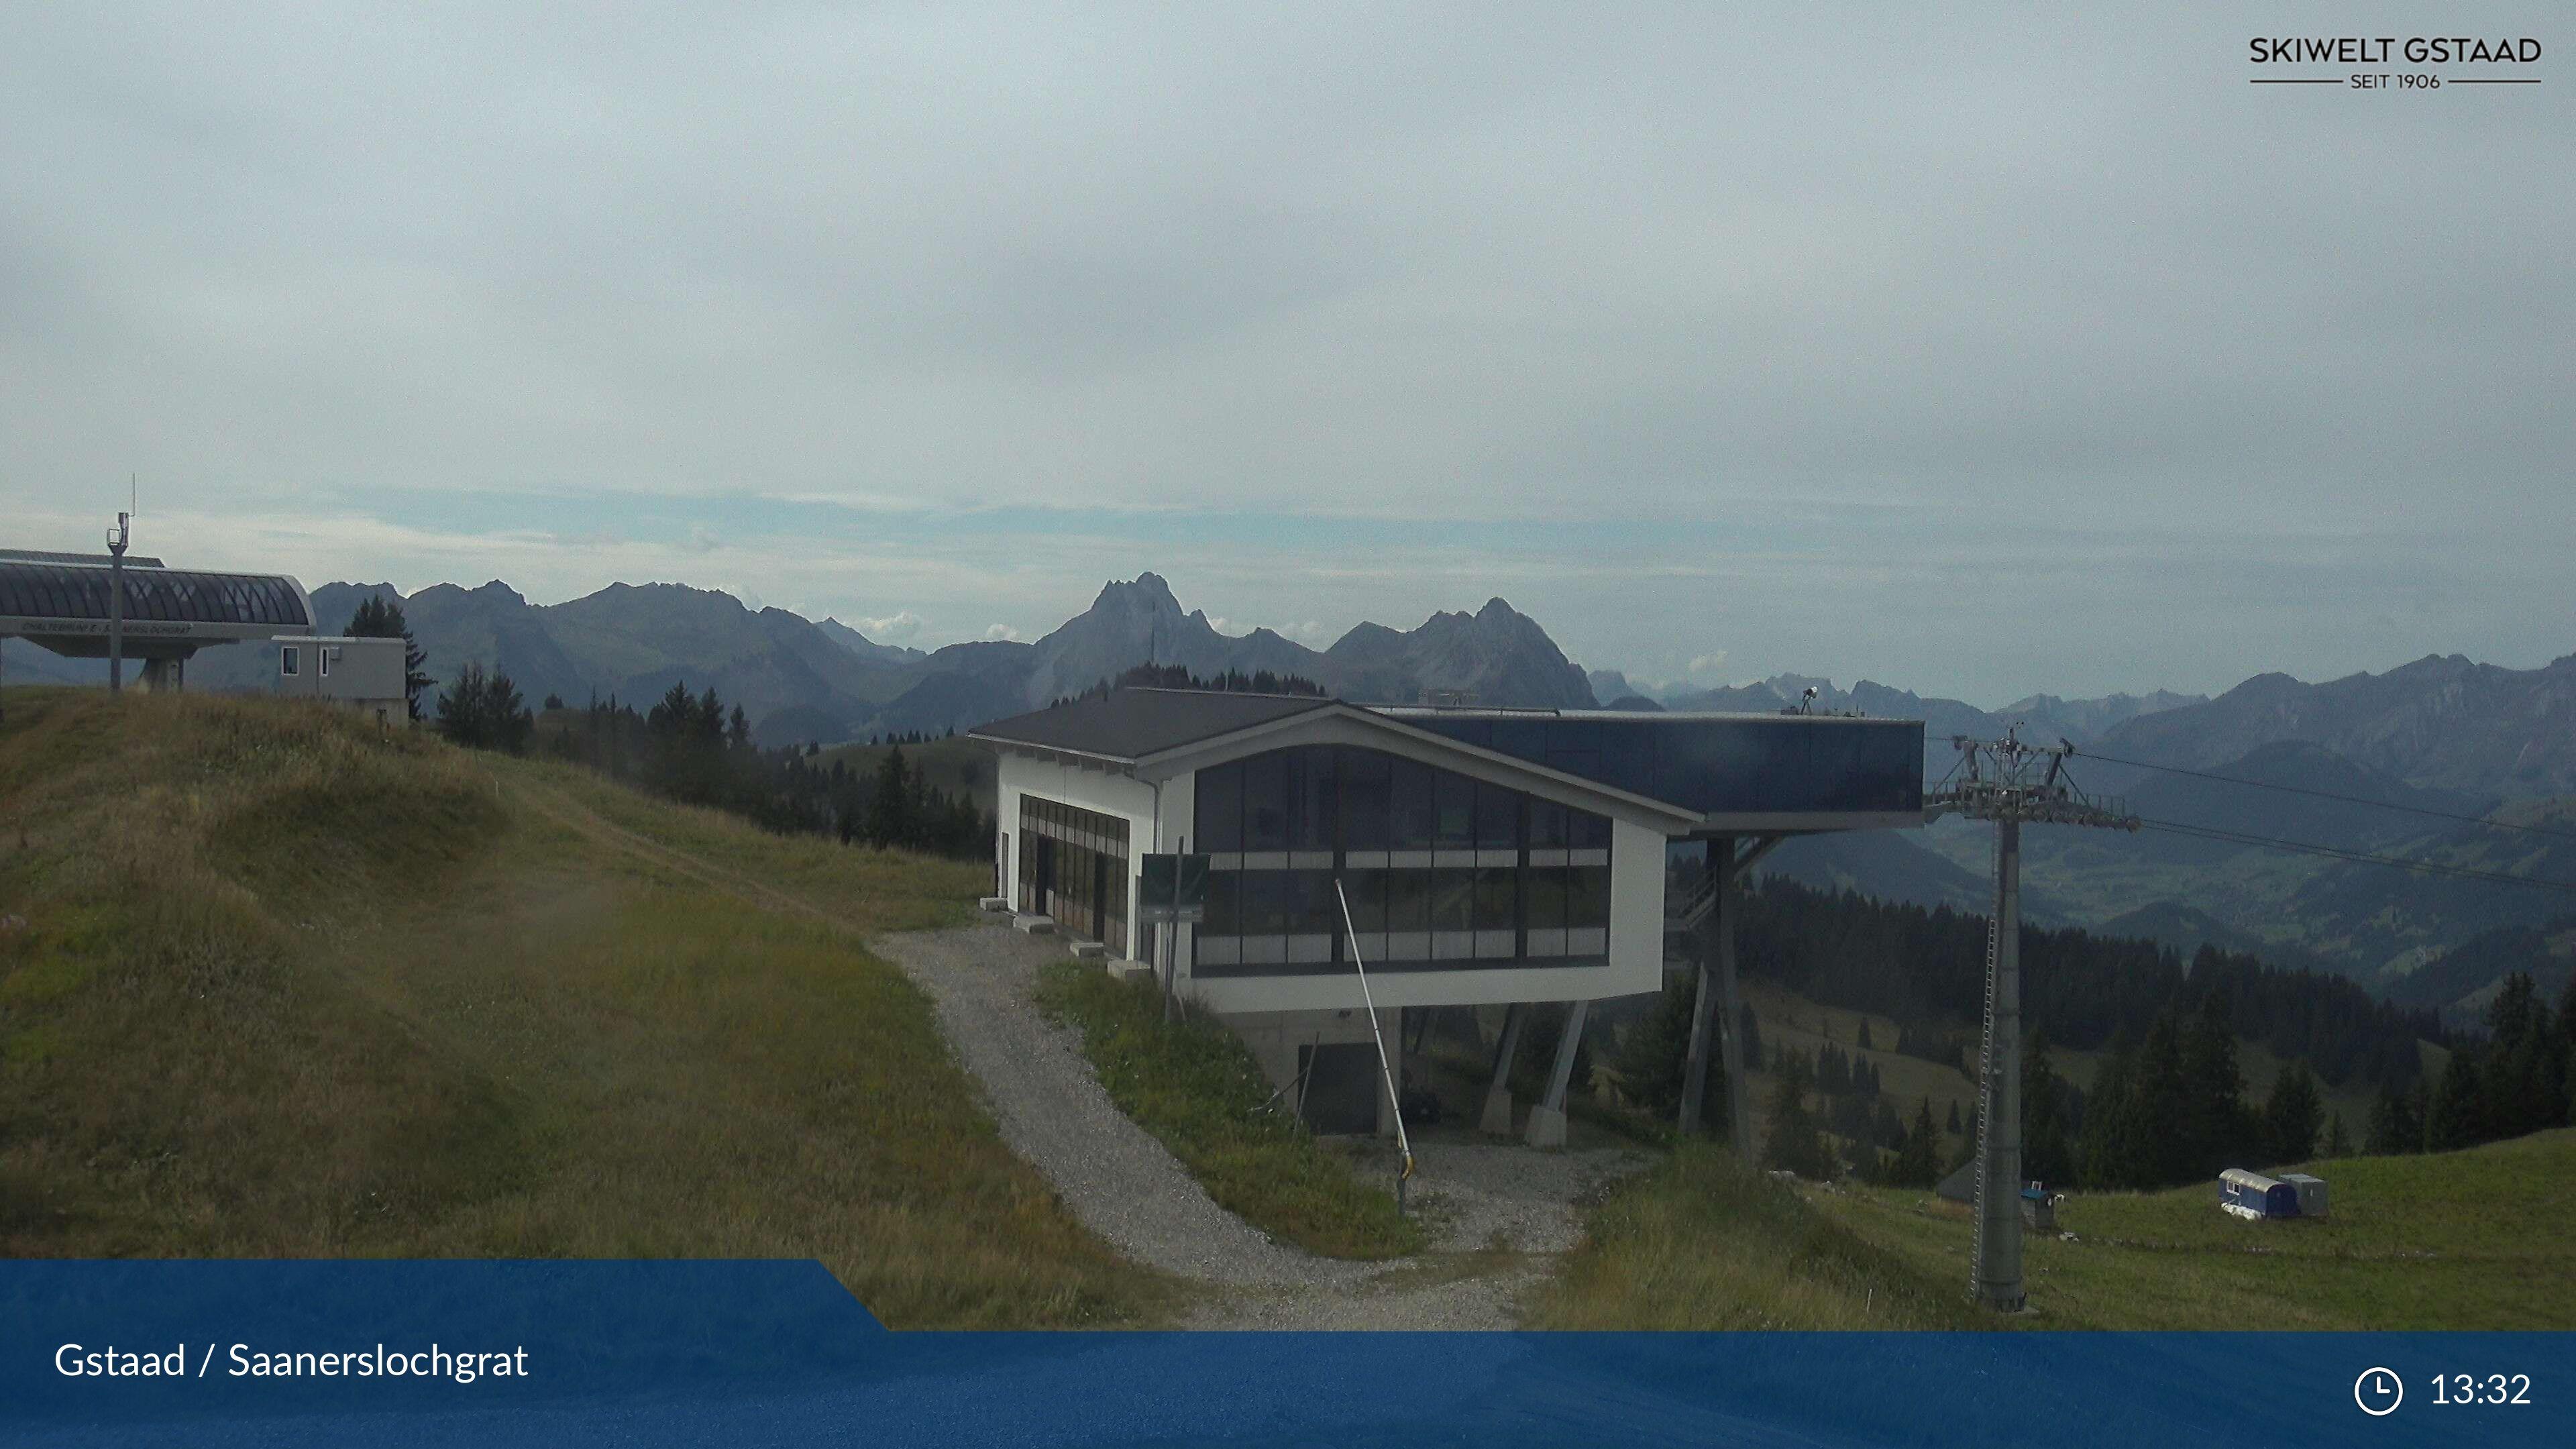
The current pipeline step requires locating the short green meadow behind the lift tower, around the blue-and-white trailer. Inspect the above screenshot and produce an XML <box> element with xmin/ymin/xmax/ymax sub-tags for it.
<box><xmin>1813</xmin><ymin>1129</ymin><xmax>2576</xmax><ymax>1328</ymax></box>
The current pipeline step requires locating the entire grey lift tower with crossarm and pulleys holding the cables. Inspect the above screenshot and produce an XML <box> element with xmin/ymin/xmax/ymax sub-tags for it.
<box><xmin>1924</xmin><ymin>724</ymin><xmax>2138</xmax><ymax>1312</ymax></box>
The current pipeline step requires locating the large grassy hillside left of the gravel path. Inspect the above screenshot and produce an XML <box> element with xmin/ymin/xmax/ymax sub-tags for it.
<box><xmin>0</xmin><ymin>688</ymin><xmax>1165</xmax><ymax>1326</ymax></box>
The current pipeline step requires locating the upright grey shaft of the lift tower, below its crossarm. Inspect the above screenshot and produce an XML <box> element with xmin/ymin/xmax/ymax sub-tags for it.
<box><xmin>1976</xmin><ymin>810</ymin><xmax>2022</xmax><ymax>1312</ymax></box>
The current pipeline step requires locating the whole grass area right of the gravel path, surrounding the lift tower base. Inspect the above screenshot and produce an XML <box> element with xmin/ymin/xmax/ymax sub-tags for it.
<box><xmin>1533</xmin><ymin>1129</ymin><xmax>2576</xmax><ymax>1330</ymax></box>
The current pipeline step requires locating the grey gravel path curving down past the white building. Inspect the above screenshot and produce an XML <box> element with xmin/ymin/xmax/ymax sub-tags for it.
<box><xmin>871</xmin><ymin>923</ymin><xmax>1638</xmax><ymax>1328</ymax></box>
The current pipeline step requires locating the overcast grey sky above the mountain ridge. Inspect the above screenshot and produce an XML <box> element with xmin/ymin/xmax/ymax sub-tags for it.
<box><xmin>0</xmin><ymin>3</ymin><xmax>2576</xmax><ymax>706</ymax></box>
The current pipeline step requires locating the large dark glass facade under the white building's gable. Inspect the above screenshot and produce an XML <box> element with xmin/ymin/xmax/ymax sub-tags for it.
<box><xmin>1190</xmin><ymin>745</ymin><xmax>1610</xmax><ymax>977</ymax></box>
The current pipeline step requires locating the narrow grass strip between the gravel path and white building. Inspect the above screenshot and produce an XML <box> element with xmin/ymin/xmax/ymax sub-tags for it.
<box><xmin>1038</xmin><ymin>962</ymin><xmax>1422</xmax><ymax>1258</ymax></box>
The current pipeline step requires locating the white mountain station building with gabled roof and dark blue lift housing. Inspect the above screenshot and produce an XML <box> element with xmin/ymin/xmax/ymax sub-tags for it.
<box><xmin>969</xmin><ymin>688</ymin><xmax>1924</xmax><ymax>1144</ymax></box>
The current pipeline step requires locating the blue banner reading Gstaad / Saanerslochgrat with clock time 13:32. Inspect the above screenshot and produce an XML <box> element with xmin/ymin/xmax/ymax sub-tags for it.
<box><xmin>0</xmin><ymin>1260</ymin><xmax>2576</xmax><ymax>1449</ymax></box>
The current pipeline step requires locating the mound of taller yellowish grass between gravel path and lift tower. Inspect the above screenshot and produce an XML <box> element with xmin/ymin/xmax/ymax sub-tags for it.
<box><xmin>1527</xmin><ymin>1142</ymin><xmax>1981</xmax><ymax>1328</ymax></box>
